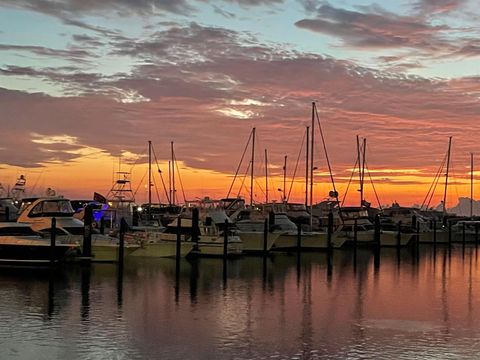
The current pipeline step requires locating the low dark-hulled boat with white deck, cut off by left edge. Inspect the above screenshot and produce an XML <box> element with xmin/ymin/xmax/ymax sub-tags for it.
<box><xmin>0</xmin><ymin>222</ymin><xmax>80</xmax><ymax>264</ymax></box>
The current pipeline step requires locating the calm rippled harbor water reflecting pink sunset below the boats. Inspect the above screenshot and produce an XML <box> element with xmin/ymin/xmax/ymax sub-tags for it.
<box><xmin>0</xmin><ymin>245</ymin><xmax>480</xmax><ymax>359</ymax></box>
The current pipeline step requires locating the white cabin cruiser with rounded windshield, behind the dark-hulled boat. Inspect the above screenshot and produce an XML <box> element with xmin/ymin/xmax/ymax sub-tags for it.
<box><xmin>17</xmin><ymin>197</ymin><xmax>139</xmax><ymax>262</ymax></box>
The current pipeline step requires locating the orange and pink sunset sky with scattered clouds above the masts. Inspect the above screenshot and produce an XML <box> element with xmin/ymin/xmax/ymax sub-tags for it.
<box><xmin>0</xmin><ymin>0</ymin><xmax>480</xmax><ymax>206</ymax></box>
